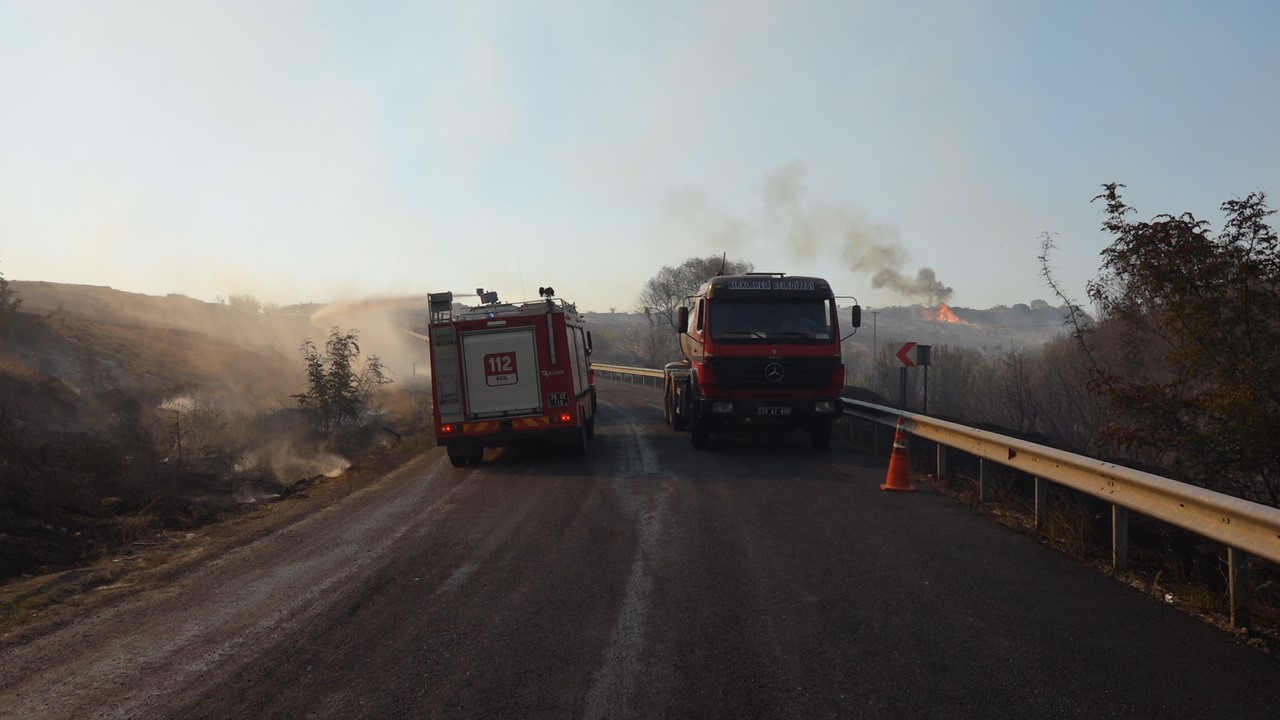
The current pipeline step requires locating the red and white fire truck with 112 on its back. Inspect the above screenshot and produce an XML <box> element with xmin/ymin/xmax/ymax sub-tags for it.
<box><xmin>428</xmin><ymin>287</ymin><xmax>596</xmax><ymax>468</ymax></box>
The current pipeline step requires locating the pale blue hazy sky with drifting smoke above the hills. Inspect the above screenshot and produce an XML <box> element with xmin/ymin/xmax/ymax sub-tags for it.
<box><xmin>0</xmin><ymin>0</ymin><xmax>1280</xmax><ymax>310</ymax></box>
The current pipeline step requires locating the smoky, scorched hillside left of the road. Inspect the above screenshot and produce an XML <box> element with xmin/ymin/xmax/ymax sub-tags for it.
<box><xmin>0</xmin><ymin>281</ymin><xmax>421</xmax><ymax>579</ymax></box>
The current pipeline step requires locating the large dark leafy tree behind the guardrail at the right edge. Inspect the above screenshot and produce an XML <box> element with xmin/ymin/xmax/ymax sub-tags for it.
<box><xmin>1082</xmin><ymin>183</ymin><xmax>1280</xmax><ymax>505</ymax></box>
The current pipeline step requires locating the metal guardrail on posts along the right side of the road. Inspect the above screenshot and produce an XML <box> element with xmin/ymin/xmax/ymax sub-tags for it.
<box><xmin>594</xmin><ymin>365</ymin><xmax>1280</xmax><ymax>625</ymax></box>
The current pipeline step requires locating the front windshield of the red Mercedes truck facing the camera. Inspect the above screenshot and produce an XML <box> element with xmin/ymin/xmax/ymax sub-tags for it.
<box><xmin>707</xmin><ymin>299</ymin><xmax>835</xmax><ymax>342</ymax></box>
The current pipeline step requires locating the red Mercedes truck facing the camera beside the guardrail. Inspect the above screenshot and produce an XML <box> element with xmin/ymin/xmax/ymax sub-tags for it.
<box><xmin>663</xmin><ymin>273</ymin><xmax>861</xmax><ymax>450</ymax></box>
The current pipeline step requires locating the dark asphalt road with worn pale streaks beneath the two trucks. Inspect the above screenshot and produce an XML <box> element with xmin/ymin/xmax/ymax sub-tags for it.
<box><xmin>0</xmin><ymin>380</ymin><xmax>1280</xmax><ymax>719</ymax></box>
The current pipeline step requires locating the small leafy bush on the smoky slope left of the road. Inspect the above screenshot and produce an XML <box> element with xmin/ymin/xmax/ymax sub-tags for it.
<box><xmin>293</xmin><ymin>327</ymin><xmax>392</xmax><ymax>432</ymax></box>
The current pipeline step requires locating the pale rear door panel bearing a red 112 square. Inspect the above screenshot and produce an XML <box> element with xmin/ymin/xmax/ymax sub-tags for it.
<box><xmin>462</xmin><ymin>327</ymin><xmax>541</xmax><ymax>418</ymax></box>
